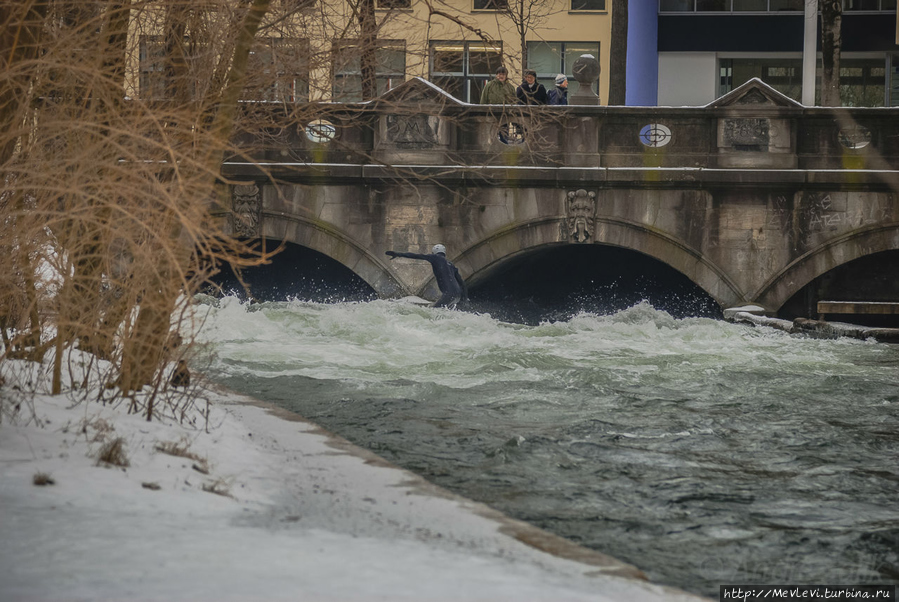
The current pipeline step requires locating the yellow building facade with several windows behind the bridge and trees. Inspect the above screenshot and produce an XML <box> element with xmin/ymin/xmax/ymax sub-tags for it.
<box><xmin>132</xmin><ymin>0</ymin><xmax>611</xmax><ymax>103</ymax></box>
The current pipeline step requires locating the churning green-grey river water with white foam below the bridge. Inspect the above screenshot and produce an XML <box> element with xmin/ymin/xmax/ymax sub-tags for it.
<box><xmin>203</xmin><ymin>298</ymin><xmax>899</xmax><ymax>595</ymax></box>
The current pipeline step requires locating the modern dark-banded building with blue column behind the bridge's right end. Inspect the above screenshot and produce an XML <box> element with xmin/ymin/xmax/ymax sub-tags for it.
<box><xmin>628</xmin><ymin>0</ymin><xmax>899</xmax><ymax>107</ymax></box>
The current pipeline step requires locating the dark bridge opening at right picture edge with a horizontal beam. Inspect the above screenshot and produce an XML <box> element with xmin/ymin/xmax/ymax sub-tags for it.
<box><xmin>778</xmin><ymin>250</ymin><xmax>899</xmax><ymax>328</ymax></box>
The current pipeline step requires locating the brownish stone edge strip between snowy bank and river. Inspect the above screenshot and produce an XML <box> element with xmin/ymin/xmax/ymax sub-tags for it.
<box><xmin>213</xmin><ymin>385</ymin><xmax>707</xmax><ymax>601</ymax></box>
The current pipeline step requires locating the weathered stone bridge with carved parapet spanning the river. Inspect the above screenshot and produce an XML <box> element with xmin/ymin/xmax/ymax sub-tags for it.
<box><xmin>223</xmin><ymin>79</ymin><xmax>899</xmax><ymax>313</ymax></box>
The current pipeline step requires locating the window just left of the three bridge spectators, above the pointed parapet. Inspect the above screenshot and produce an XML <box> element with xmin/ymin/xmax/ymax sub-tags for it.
<box><xmin>430</xmin><ymin>42</ymin><xmax>503</xmax><ymax>103</ymax></box>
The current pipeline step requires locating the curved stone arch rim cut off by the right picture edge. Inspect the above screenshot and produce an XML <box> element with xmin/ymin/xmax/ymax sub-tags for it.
<box><xmin>754</xmin><ymin>223</ymin><xmax>899</xmax><ymax>311</ymax></box>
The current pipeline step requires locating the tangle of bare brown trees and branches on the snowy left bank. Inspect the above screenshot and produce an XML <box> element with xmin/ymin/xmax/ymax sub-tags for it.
<box><xmin>0</xmin><ymin>0</ymin><xmax>276</xmax><ymax>410</ymax></box>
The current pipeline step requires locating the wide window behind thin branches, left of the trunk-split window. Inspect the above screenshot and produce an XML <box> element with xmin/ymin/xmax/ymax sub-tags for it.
<box><xmin>243</xmin><ymin>38</ymin><xmax>309</xmax><ymax>102</ymax></box>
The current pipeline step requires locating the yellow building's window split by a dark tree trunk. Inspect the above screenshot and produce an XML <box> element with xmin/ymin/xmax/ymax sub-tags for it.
<box><xmin>332</xmin><ymin>40</ymin><xmax>406</xmax><ymax>102</ymax></box>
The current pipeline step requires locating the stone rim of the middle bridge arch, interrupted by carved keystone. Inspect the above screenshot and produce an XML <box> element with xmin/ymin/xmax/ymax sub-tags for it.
<box><xmin>421</xmin><ymin>217</ymin><xmax>745</xmax><ymax>307</ymax></box>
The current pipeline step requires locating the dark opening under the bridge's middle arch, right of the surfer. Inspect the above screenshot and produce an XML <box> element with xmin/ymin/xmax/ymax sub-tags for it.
<box><xmin>470</xmin><ymin>244</ymin><xmax>721</xmax><ymax>323</ymax></box>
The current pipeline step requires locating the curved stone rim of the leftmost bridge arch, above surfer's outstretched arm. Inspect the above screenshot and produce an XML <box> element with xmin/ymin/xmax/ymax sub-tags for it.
<box><xmin>259</xmin><ymin>212</ymin><xmax>407</xmax><ymax>298</ymax></box>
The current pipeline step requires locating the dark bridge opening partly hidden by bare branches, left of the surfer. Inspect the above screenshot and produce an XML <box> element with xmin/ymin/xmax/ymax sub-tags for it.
<box><xmin>213</xmin><ymin>239</ymin><xmax>378</xmax><ymax>303</ymax></box>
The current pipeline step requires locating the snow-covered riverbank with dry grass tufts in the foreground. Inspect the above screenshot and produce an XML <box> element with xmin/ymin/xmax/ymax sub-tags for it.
<box><xmin>0</xmin><ymin>382</ymin><xmax>712</xmax><ymax>602</ymax></box>
